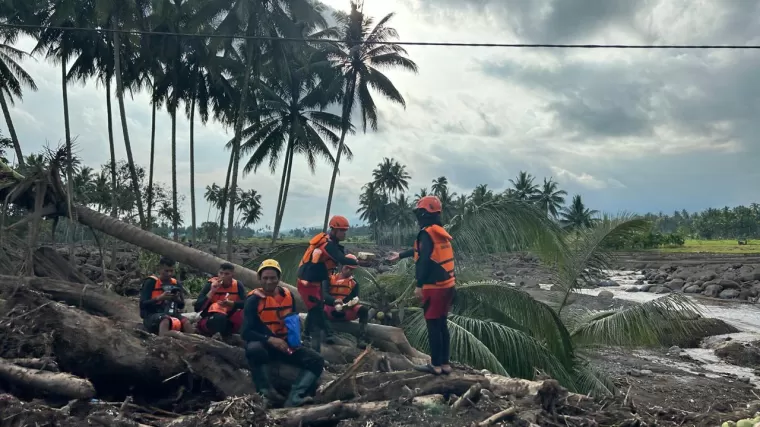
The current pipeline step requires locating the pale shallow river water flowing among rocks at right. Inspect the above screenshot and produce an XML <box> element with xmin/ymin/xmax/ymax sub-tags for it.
<box><xmin>541</xmin><ymin>271</ymin><xmax>760</xmax><ymax>387</ymax></box>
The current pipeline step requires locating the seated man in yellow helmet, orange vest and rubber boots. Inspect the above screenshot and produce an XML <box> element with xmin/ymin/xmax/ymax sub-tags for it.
<box><xmin>241</xmin><ymin>259</ymin><xmax>325</xmax><ymax>408</ymax></box>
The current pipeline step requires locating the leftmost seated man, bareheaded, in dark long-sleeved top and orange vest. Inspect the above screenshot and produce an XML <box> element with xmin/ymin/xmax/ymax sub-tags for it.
<box><xmin>140</xmin><ymin>257</ymin><xmax>193</xmax><ymax>335</ymax></box>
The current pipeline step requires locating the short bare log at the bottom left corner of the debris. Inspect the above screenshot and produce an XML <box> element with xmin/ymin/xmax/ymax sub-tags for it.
<box><xmin>0</xmin><ymin>359</ymin><xmax>95</xmax><ymax>399</ymax></box>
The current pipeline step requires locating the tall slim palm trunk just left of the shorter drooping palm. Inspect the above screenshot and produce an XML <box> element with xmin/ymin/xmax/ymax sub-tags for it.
<box><xmin>227</xmin><ymin>30</ymin><xmax>258</xmax><ymax>258</ymax></box>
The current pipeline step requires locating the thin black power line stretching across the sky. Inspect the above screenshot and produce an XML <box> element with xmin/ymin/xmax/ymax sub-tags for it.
<box><xmin>0</xmin><ymin>23</ymin><xmax>760</xmax><ymax>50</ymax></box>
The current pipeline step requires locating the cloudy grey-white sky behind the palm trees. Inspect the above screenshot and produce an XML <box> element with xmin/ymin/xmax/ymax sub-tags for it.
<box><xmin>3</xmin><ymin>0</ymin><xmax>760</xmax><ymax>232</ymax></box>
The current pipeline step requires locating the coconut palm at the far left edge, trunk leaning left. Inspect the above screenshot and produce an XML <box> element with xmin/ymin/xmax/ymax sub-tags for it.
<box><xmin>0</xmin><ymin>30</ymin><xmax>37</xmax><ymax>168</ymax></box>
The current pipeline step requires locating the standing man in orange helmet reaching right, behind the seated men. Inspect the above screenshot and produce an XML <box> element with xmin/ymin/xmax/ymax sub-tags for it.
<box><xmin>298</xmin><ymin>215</ymin><xmax>359</xmax><ymax>352</ymax></box>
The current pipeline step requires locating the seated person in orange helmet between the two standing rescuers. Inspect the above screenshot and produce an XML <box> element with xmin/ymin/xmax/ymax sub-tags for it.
<box><xmin>322</xmin><ymin>254</ymin><xmax>369</xmax><ymax>348</ymax></box>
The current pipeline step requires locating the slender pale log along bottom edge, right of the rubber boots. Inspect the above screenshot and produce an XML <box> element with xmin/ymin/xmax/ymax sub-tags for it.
<box><xmin>269</xmin><ymin>395</ymin><xmax>444</xmax><ymax>427</ymax></box>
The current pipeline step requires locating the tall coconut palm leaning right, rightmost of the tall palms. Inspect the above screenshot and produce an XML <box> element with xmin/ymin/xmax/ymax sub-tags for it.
<box><xmin>322</xmin><ymin>0</ymin><xmax>417</xmax><ymax>230</ymax></box>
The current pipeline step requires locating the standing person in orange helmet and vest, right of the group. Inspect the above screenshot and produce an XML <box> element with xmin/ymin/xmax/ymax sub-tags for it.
<box><xmin>388</xmin><ymin>196</ymin><xmax>456</xmax><ymax>375</ymax></box>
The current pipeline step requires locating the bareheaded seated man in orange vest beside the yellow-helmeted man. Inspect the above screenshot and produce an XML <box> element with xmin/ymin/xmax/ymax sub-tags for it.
<box><xmin>195</xmin><ymin>262</ymin><xmax>246</xmax><ymax>338</ymax></box>
